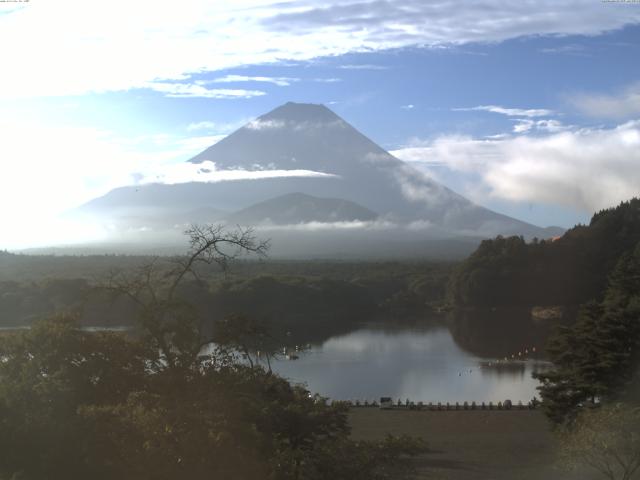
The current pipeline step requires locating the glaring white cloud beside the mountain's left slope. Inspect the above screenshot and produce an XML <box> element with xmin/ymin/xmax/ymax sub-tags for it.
<box><xmin>0</xmin><ymin>119</ymin><xmax>228</xmax><ymax>244</ymax></box>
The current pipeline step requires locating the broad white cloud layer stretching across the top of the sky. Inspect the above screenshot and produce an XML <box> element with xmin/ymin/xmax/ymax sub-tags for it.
<box><xmin>0</xmin><ymin>0</ymin><xmax>640</xmax><ymax>98</ymax></box>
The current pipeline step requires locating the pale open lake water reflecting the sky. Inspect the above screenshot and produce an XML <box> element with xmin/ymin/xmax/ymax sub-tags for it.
<box><xmin>273</xmin><ymin>327</ymin><xmax>548</xmax><ymax>403</ymax></box>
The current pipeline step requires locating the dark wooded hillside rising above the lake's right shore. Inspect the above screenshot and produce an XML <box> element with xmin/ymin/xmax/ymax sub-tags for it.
<box><xmin>447</xmin><ymin>198</ymin><xmax>640</xmax><ymax>307</ymax></box>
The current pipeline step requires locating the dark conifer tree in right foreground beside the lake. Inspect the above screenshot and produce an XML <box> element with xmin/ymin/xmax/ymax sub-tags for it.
<box><xmin>537</xmin><ymin>243</ymin><xmax>640</xmax><ymax>424</ymax></box>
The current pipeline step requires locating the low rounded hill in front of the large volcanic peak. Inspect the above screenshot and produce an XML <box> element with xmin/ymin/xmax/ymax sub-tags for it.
<box><xmin>227</xmin><ymin>193</ymin><xmax>378</xmax><ymax>225</ymax></box>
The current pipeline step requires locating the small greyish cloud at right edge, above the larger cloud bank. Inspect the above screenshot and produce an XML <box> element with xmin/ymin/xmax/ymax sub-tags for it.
<box><xmin>569</xmin><ymin>82</ymin><xmax>640</xmax><ymax>119</ymax></box>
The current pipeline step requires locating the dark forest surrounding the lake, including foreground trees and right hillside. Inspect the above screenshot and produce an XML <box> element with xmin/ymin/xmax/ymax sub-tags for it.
<box><xmin>0</xmin><ymin>199</ymin><xmax>640</xmax><ymax>480</ymax></box>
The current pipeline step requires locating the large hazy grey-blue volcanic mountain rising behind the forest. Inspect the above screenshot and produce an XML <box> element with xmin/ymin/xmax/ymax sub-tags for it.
<box><xmin>80</xmin><ymin>103</ymin><xmax>563</xmax><ymax>256</ymax></box>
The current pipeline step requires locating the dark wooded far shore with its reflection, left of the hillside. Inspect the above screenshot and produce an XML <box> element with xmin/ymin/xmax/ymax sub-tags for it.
<box><xmin>209</xmin><ymin>272</ymin><xmax>447</xmax><ymax>342</ymax></box>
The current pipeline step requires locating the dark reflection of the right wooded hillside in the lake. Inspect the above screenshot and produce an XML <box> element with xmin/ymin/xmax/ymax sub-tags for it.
<box><xmin>447</xmin><ymin>308</ymin><xmax>555</xmax><ymax>358</ymax></box>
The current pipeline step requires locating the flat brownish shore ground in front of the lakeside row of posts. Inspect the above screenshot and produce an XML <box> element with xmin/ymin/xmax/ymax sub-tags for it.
<box><xmin>350</xmin><ymin>408</ymin><xmax>597</xmax><ymax>480</ymax></box>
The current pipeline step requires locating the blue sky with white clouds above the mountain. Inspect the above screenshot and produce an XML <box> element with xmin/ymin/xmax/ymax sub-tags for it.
<box><xmin>0</xmin><ymin>0</ymin><xmax>640</xmax><ymax>244</ymax></box>
